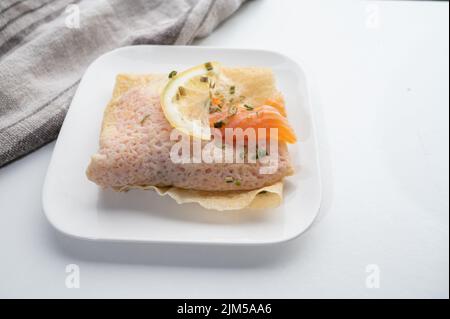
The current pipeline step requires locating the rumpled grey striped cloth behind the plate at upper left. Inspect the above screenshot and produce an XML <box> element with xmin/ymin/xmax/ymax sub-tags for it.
<box><xmin>0</xmin><ymin>0</ymin><xmax>245</xmax><ymax>167</ymax></box>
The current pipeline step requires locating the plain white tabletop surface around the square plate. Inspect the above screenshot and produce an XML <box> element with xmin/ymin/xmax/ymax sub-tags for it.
<box><xmin>0</xmin><ymin>0</ymin><xmax>449</xmax><ymax>298</ymax></box>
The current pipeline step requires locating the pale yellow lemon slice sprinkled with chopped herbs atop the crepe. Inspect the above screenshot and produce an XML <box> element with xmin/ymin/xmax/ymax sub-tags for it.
<box><xmin>161</xmin><ymin>62</ymin><xmax>220</xmax><ymax>140</ymax></box>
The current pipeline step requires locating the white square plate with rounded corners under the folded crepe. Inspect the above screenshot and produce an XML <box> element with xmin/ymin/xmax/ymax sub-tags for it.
<box><xmin>43</xmin><ymin>46</ymin><xmax>321</xmax><ymax>244</ymax></box>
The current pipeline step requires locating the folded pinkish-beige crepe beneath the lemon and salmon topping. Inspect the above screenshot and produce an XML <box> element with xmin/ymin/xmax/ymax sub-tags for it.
<box><xmin>87</xmin><ymin>68</ymin><xmax>293</xmax><ymax>210</ymax></box>
